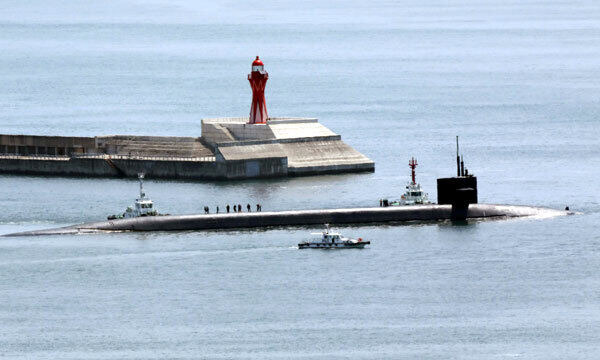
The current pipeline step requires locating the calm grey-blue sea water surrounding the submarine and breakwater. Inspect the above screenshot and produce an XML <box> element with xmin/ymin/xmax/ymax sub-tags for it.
<box><xmin>0</xmin><ymin>0</ymin><xmax>600</xmax><ymax>359</ymax></box>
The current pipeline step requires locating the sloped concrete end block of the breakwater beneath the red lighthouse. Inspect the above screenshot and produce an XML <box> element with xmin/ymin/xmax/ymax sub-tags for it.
<box><xmin>202</xmin><ymin>118</ymin><xmax>375</xmax><ymax>177</ymax></box>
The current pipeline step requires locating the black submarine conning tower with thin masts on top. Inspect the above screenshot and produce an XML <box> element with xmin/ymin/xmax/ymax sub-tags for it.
<box><xmin>437</xmin><ymin>136</ymin><xmax>477</xmax><ymax>219</ymax></box>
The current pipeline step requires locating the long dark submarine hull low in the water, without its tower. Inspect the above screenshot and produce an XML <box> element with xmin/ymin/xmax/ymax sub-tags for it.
<box><xmin>5</xmin><ymin>204</ymin><xmax>568</xmax><ymax>236</ymax></box>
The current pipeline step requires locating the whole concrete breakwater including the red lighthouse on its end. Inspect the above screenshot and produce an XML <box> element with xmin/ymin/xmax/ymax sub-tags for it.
<box><xmin>0</xmin><ymin>56</ymin><xmax>375</xmax><ymax>179</ymax></box>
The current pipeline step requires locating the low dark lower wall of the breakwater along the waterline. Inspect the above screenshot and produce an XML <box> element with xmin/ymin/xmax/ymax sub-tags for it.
<box><xmin>0</xmin><ymin>155</ymin><xmax>373</xmax><ymax>180</ymax></box>
